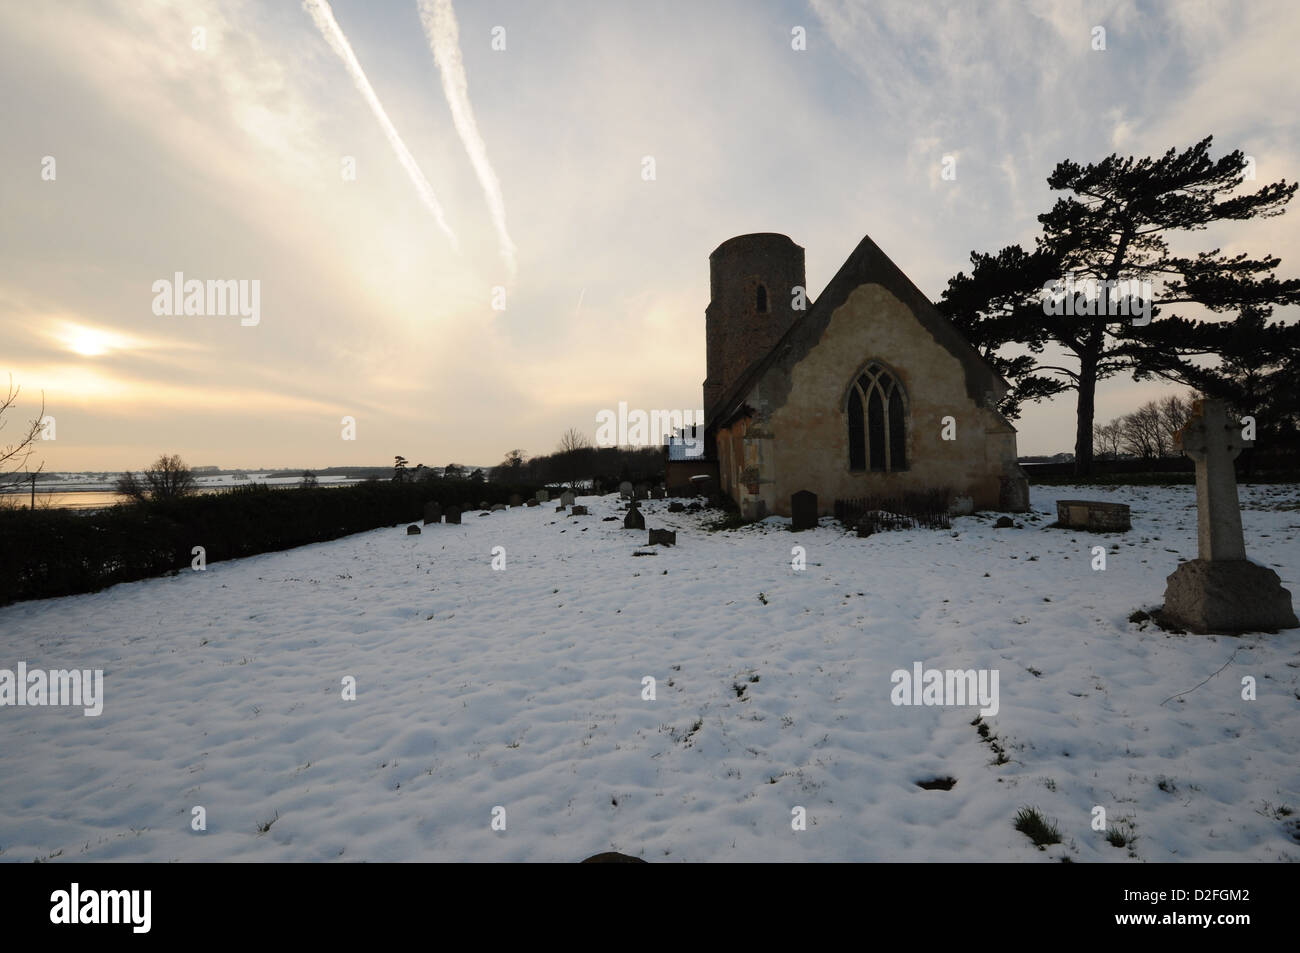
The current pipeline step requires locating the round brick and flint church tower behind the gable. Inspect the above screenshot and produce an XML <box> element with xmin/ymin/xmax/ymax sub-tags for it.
<box><xmin>705</xmin><ymin>231</ymin><xmax>807</xmax><ymax>420</ymax></box>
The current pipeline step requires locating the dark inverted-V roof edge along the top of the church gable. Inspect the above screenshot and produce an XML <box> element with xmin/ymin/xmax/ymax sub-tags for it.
<box><xmin>706</xmin><ymin>235</ymin><xmax>1010</xmax><ymax>434</ymax></box>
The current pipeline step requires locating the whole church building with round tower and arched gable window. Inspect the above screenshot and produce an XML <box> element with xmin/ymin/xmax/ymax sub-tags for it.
<box><xmin>691</xmin><ymin>233</ymin><xmax>1028</xmax><ymax>519</ymax></box>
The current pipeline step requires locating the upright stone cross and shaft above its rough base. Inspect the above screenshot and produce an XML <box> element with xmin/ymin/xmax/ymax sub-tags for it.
<box><xmin>1177</xmin><ymin>400</ymin><xmax>1253</xmax><ymax>560</ymax></box>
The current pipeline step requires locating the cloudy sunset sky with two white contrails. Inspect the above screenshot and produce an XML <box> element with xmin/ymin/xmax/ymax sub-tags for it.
<box><xmin>0</xmin><ymin>0</ymin><xmax>1300</xmax><ymax>471</ymax></box>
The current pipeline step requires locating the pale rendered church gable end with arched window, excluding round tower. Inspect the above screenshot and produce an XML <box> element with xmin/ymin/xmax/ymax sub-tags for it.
<box><xmin>710</xmin><ymin>230</ymin><xmax>1023</xmax><ymax>516</ymax></box>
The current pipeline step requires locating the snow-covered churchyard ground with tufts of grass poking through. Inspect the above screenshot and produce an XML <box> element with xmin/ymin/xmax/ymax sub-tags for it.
<box><xmin>0</xmin><ymin>486</ymin><xmax>1300</xmax><ymax>863</ymax></box>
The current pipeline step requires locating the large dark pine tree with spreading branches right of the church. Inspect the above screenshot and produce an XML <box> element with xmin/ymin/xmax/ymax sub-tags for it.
<box><xmin>937</xmin><ymin>137</ymin><xmax>1300</xmax><ymax>475</ymax></box>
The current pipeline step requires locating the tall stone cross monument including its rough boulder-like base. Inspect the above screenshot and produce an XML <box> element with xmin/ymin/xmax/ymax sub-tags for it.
<box><xmin>1162</xmin><ymin>400</ymin><xmax>1300</xmax><ymax>634</ymax></box>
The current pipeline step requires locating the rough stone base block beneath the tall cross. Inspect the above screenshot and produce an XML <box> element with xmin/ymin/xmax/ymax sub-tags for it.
<box><xmin>1161</xmin><ymin>559</ymin><xmax>1300</xmax><ymax>634</ymax></box>
